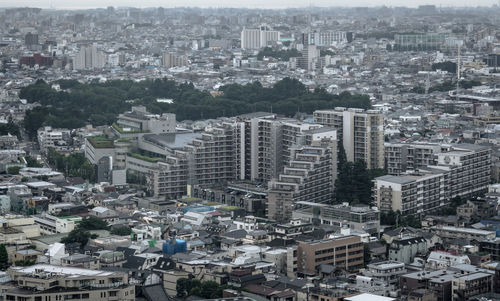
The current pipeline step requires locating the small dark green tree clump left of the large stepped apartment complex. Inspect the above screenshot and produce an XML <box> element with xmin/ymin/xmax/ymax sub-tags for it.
<box><xmin>47</xmin><ymin>148</ymin><xmax>94</xmax><ymax>182</ymax></box>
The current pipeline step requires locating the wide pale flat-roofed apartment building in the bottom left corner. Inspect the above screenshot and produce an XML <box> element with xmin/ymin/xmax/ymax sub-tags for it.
<box><xmin>2</xmin><ymin>264</ymin><xmax>135</xmax><ymax>301</ymax></box>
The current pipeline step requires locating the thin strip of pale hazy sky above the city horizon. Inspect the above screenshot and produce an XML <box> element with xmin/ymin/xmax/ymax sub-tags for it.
<box><xmin>0</xmin><ymin>0</ymin><xmax>499</xmax><ymax>9</ymax></box>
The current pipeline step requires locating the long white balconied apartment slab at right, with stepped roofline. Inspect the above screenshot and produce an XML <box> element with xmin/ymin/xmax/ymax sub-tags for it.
<box><xmin>373</xmin><ymin>144</ymin><xmax>491</xmax><ymax>215</ymax></box>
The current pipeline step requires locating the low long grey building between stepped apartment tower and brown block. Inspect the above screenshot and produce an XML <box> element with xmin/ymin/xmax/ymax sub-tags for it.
<box><xmin>292</xmin><ymin>202</ymin><xmax>380</xmax><ymax>235</ymax></box>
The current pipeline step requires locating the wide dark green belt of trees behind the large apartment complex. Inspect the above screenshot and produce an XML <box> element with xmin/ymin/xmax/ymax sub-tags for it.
<box><xmin>20</xmin><ymin>78</ymin><xmax>370</xmax><ymax>137</ymax></box>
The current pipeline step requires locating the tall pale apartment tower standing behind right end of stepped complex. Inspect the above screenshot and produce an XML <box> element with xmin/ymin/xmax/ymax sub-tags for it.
<box><xmin>313</xmin><ymin>107</ymin><xmax>384</xmax><ymax>168</ymax></box>
